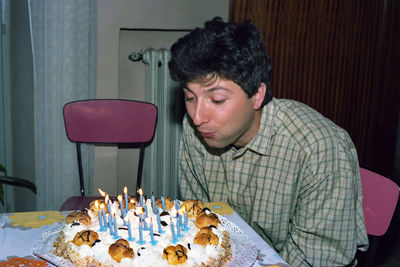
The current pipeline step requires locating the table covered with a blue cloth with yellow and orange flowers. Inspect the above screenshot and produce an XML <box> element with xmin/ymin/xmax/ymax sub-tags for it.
<box><xmin>0</xmin><ymin>202</ymin><xmax>289</xmax><ymax>267</ymax></box>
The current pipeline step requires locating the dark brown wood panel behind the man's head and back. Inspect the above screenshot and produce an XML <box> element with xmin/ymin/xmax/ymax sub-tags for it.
<box><xmin>230</xmin><ymin>0</ymin><xmax>400</xmax><ymax>180</ymax></box>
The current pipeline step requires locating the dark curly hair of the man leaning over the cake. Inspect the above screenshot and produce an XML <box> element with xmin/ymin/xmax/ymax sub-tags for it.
<box><xmin>168</xmin><ymin>17</ymin><xmax>272</xmax><ymax>105</ymax></box>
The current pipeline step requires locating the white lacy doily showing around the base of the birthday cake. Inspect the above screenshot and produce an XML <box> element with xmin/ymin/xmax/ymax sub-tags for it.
<box><xmin>33</xmin><ymin>215</ymin><xmax>258</xmax><ymax>267</ymax></box>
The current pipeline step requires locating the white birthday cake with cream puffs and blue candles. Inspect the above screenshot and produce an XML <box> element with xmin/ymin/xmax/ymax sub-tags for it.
<box><xmin>54</xmin><ymin>195</ymin><xmax>232</xmax><ymax>267</ymax></box>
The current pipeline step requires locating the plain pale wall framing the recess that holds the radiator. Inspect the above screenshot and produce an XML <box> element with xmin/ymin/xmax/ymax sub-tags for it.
<box><xmin>93</xmin><ymin>0</ymin><xmax>229</xmax><ymax>195</ymax></box>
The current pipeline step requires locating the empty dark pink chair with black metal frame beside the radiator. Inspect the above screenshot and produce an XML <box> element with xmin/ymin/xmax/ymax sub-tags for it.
<box><xmin>60</xmin><ymin>99</ymin><xmax>157</xmax><ymax>213</ymax></box>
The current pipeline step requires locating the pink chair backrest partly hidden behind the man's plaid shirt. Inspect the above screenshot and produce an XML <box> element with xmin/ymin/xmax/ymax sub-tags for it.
<box><xmin>360</xmin><ymin>168</ymin><xmax>399</xmax><ymax>236</ymax></box>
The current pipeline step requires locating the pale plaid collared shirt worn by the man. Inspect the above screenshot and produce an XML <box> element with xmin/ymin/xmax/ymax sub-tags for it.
<box><xmin>179</xmin><ymin>98</ymin><xmax>368</xmax><ymax>266</ymax></box>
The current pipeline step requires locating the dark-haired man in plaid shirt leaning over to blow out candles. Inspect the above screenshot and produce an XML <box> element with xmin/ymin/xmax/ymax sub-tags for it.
<box><xmin>169</xmin><ymin>18</ymin><xmax>368</xmax><ymax>266</ymax></box>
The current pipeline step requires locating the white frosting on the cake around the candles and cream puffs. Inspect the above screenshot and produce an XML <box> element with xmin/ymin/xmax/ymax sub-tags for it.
<box><xmin>63</xmin><ymin>199</ymin><xmax>225</xmax><ymax>267</ymax></box>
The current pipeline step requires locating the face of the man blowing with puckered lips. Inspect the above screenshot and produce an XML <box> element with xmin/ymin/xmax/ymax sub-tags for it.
<box><xmin>183</xmin><ymin>77</ymin><xmax>263</xmax><ymax>148</ymax></box>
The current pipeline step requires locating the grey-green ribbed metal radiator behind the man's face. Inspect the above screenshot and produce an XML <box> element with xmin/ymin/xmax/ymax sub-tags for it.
<box><xmin>130</xmin><ymin>49</ymin><xmax>184</xmax><ymax>198</ymax></box>
